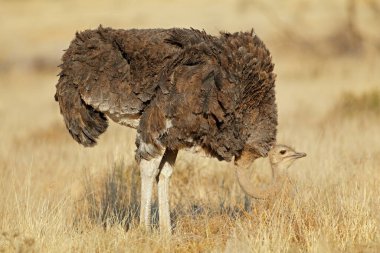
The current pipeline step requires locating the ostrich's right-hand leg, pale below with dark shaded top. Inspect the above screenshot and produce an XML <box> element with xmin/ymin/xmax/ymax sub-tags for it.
<box><xmin>158</xmin><ymin>149</ymin><xmax>178</xmax><ymax>234</ymax></box>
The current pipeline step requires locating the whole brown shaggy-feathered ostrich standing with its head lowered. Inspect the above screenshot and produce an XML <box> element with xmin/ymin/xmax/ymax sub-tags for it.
<box><xmin>55</xmin><ymin>26</ymin><xmax>302</xmax><ymax>232</ymax></box>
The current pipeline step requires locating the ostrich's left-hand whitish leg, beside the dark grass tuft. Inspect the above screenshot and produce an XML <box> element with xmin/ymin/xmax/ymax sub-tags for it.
<box><xmin>140</xmin><ymin>156</ymin><xmax>162</xmax><ymax>229</ymax></box>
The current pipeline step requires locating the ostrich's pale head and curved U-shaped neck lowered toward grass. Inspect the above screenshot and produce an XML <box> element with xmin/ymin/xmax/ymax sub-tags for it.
<box><xmin>236</xmin><ymin>144</ymin><xmax>306</xmax><ymax>199</ymax></box>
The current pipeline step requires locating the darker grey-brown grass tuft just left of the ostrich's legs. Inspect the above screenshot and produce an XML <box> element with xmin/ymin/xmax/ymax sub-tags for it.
<box><xmin>77</xmin><ymin>161</ymin><xmax>139</xmax><ymax>230</ymax></box>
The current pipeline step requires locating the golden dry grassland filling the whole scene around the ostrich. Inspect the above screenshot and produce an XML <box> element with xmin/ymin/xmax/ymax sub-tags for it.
<box><xmin>0</xmin><ymin>0</ymin><xmax>380</xmax><ymax>252</ymax></box>
